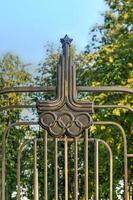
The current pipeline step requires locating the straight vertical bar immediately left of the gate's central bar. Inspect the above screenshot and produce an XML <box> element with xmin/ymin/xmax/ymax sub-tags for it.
<box><xmin>54</xmin><ymin>138</ymin><xmax>58</xmax><ymax>200</ymax></box>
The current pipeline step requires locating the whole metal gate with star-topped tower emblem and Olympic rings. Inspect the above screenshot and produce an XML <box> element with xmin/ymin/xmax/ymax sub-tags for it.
<box><xmin>0</xmin><ymin>36</ymin><xmax>133</xmax><ymax>200</ymax></box>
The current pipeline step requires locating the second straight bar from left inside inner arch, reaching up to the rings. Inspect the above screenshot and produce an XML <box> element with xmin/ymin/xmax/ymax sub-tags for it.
<box><xmin>44</xmin><ymin>131</ymin><xmax>48</xmax><ymax>200</ymax></box>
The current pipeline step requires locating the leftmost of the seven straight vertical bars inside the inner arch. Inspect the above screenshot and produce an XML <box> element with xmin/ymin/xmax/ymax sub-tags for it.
<box><xmin>34</xmin><ymin>139</ymin><xmax>38</xmax><ymax>200</ymax></box>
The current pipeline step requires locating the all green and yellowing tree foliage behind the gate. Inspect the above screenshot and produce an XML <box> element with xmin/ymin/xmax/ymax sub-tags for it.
<box><xmin>0</xmin><ymin>0</ymin><xmax>133</xmax><ymax>200</ymax></box>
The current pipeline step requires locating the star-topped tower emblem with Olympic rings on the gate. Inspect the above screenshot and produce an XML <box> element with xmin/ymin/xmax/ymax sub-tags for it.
<box><xmin>37</xmin><ymin>35</ymin><xmax>93</xmax><ymax>137</ymax></box>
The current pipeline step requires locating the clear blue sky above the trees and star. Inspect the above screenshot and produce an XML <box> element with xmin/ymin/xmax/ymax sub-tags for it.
<box><xmin>0</xmin><ymin>0</ymin><xmax>105</xmax><ymax>64</ymax></box>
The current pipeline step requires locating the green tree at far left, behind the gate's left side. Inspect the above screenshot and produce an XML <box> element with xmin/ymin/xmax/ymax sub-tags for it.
<box><xmin>0</xmin><ymin>53</ymin><xmax>31</xmax><ymax>200</ymax></box>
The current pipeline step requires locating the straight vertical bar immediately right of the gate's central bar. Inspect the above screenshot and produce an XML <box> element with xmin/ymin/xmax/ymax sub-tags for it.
<box><xmin>74</xmin><ymin>137</ymin><xmax>78</xmax><ymax>200</ymax></box>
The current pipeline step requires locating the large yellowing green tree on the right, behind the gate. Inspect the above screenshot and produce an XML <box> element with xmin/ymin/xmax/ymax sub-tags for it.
<box><xmin>77</xmin><ymin>0</ymin><xmax>133</xmax><ymax>199</ymax></box>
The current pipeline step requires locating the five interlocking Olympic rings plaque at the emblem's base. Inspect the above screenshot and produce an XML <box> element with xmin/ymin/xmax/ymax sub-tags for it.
<box><xmin>40</xmin><ymin>111</ymin><xmax>92</xmax><ymax>137</ymax></box>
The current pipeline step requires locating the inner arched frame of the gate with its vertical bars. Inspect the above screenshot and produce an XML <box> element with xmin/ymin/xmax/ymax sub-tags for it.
<box><xmin>17</xmin><ymin>130</ymin><xmax>113</xmax><ymax>200</ymax></box>
